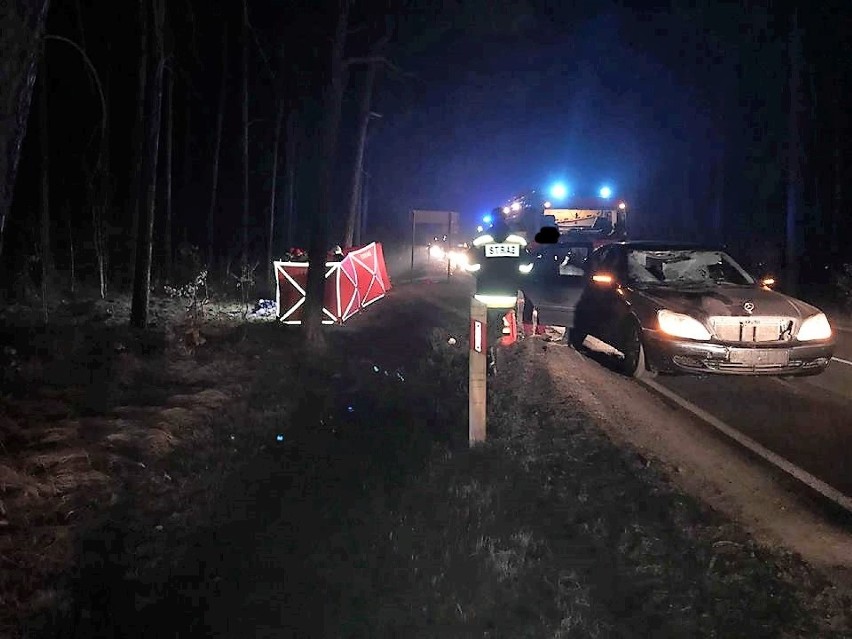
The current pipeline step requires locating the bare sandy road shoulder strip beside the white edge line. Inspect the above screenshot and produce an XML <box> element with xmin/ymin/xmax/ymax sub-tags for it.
<box><xmin>535</xmin><ymin>343</ymin><xmax>852</xmax><ymax>584</ymax></box>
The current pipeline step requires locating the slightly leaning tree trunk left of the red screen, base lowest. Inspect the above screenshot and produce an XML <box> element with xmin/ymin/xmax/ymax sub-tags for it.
<box><xmin>130</xmin><ymin>0</ymin><xmax>165</xmax><ymax>328</ymax></box>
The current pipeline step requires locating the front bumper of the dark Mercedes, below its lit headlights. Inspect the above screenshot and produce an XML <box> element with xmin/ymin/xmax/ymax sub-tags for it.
<box><xmin>643</xmin><ymin>330</ymin><xmax>834</xmax><ymax>375</ymax></box>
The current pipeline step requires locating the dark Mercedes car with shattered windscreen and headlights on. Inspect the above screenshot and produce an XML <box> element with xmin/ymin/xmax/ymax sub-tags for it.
<box><xmin>570</xmin><ymin>241</ymin><xmax>835</xmax><ymax>377</ymax></box>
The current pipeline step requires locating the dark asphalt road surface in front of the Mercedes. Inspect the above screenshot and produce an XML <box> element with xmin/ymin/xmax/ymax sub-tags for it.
<box><xmin>656</xmin><ymin>329</ymin><xmax>852</xmax><ymax>497</ymax></box>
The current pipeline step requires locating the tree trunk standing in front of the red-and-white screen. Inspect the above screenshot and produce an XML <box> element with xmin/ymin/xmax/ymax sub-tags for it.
<box><xmin>303</xmin><ymin>0</ymin><xmax>350</xmax><ymax>349</ymax></box>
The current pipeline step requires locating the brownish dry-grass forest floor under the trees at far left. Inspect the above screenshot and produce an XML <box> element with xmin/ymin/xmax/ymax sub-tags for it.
<box><xmin>0</xmin><ymin>300</ymin><xmax>286</xmax><ymax>636</ymax></box>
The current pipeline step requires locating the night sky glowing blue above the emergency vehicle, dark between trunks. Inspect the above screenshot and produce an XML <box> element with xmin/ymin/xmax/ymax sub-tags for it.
<box><xmin>6</xmin><ymin>0</ymin><xmax>852</xmax><ymax>280</ymax></box>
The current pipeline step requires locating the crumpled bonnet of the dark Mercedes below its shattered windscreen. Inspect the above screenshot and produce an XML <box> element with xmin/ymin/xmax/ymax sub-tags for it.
<box><xmin>633</xmin><ymin>284</ymin><xmax>820</xmax><ymax>320</ymax></box>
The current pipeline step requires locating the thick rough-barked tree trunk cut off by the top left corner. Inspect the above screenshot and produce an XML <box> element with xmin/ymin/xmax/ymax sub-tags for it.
<box><xmin>0</xmin><ymin>0</ymin><xmax>50</xmax><ymax>256</ymax></box>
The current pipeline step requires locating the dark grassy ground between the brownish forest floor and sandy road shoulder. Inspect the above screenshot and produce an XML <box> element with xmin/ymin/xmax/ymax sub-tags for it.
<box><xmin>3</xmin><ymin>272</ymin><xmax>852</xmax><ymax>638</ymax></box>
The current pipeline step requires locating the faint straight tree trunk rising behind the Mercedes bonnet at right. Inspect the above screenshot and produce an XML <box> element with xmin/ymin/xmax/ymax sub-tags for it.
<box><xmin>784</xmin><ymin>10</ymin><xmax>803</xmax><ymax>295</ymax></box>
